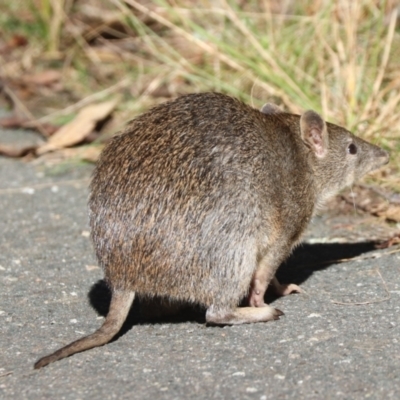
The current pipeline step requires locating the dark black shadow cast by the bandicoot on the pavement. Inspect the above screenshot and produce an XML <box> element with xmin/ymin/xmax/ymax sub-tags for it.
<box><xmin>88</xmin><ymin>242</ymin><xmax>376</xmax><ymax>340</ymax></box>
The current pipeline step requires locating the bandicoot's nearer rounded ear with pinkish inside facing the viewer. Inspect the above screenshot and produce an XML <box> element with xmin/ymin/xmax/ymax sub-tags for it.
<box><xmin>300</xmin><ymin>110</ymin><xmax>329</xmax><ymax>158</ymax></box>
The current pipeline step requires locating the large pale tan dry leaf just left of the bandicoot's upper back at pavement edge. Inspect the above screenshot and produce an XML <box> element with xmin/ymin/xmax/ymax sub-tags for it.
<box><xmin>37</xmin><ymin>100</ymin><xmax>118</xmax><ymax>155</ymax></box>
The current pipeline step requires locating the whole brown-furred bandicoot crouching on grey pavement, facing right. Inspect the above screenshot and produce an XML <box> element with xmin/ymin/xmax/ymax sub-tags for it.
<box><xmin>36</xmin><ymin>93</ymin><xmax>388</xmax><ymax>368</ymax></box>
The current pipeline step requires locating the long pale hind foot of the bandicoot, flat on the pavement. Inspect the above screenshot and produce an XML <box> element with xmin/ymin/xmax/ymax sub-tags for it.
<box><xmin>206</xmin><ymin>304</ymin><xmax>284</xmax><ymax>325</ymax></box>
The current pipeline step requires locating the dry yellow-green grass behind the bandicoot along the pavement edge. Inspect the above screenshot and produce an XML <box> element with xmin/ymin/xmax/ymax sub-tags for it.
<box><xmin>0</xmin><ymin>0</ymin><xmax>400</xmax><ymax>191</ymax></box>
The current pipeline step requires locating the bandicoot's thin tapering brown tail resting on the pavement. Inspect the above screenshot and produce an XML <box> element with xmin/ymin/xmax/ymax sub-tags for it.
<box><xmin>35</xmin><ymin>291</ymin><xmax>135</xmax><ymax>369</ymax></box>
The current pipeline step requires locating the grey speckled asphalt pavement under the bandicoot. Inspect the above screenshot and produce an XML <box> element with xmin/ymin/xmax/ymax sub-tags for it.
<box><xmin>0</xmin><ymin>123</ymin><xmax>400</xmax><ymax>399</ymax></box>
